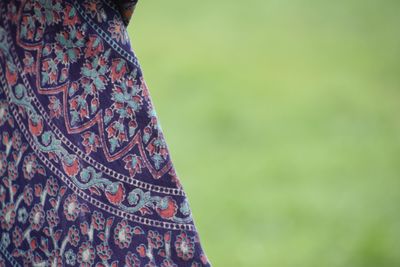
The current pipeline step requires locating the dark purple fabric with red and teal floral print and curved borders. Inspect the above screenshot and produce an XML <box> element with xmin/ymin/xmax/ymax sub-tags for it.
<box><xmin>0</xmin><ymin>0</ymin><xmax>210</xmax><ymax>267</ymax></box>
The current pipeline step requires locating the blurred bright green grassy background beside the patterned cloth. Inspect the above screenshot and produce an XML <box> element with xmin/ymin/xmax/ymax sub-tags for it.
<box><xmin>128</xmin><ymin>0</ymin><xmax>400</xmax><ymax>267</ymax></box>
